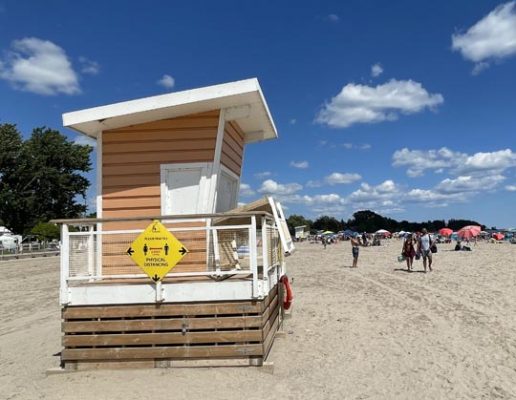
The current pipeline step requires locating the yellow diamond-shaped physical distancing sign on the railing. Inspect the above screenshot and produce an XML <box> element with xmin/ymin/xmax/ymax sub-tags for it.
<box><xmin>127</xmin><ymin>220</ymin><xmax>188</xmax><ymax>282</ymax></box>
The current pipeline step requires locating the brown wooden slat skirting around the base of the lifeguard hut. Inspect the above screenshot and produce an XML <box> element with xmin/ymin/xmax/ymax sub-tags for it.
<box><xmin>61</xmin><ymin>287</ymin><xmax>280</xmax><ymax>369</ymax></box>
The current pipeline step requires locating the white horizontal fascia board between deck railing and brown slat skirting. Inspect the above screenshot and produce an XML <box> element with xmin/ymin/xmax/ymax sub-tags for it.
<box><xmin>62</xmin><ymin>280</ymin><xmax>253</xmax><ymax>306</ymax></box>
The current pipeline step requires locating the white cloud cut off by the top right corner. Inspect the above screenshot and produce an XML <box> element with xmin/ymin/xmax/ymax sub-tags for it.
<box><xmin>452</xmin><ymin>1</ymin><xmax>516</xmax><ymax>73</ymax></box>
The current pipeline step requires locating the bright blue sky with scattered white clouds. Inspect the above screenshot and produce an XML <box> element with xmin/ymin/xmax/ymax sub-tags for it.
<box><xmin>0</xmin><ymin>0</ymin><xmax>516</xmax><ymax>227</ymax></box>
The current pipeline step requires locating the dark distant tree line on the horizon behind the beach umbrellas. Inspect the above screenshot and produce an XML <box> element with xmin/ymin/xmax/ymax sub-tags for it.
<box><xmin>287</xmin><ymin>210</ymin><xmax>485</xmax><ymax>234</ymax></box>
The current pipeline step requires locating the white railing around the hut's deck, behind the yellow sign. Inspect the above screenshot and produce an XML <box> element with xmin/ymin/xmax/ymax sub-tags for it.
<box><xmin>54</xmin><ymin>212</ymin><xmax>283</xmax><ymax>299</ymax></box>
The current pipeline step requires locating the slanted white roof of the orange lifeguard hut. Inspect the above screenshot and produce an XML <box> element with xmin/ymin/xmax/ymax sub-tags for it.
<box><xmin>63</xmin><ymin>78</ymin><xmax>278</xmax><ymax>143</ymax></box>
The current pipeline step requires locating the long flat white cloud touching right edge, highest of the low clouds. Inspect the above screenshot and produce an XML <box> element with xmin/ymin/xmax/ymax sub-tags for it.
<box><xmin>392</xmin><ymin>147</ymin><xmax>516</xmax><ymax>177</ymax></box>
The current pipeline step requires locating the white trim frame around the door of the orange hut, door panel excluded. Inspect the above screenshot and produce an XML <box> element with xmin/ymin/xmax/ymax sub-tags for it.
<box><xmin>160</xmin><ymin>162</ymin><xmax>211</xmax><ymax>216</ymax></box>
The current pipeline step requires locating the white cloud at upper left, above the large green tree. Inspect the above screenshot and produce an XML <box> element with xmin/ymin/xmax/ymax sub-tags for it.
<box><xmin>0</xmin><ymin>37</ymin><xmax>81</xmax><ymax>95</ymax></box>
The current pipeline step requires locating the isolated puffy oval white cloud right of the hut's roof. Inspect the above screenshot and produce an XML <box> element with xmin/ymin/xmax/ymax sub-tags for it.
<box><xmin>316</xmin><ymin>79</ymin><xmax>444</xmax><ymax>128</ymax></box>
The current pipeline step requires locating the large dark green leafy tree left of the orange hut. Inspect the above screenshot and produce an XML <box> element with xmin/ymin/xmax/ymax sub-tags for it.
<box><xmin>0</xmin><ymin>124</ymin><xmax>92</xmax><ymax>233</ymax></box>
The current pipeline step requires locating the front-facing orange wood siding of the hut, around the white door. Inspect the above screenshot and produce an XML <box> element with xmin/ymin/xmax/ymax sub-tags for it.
<box><xmin>102</xmin><ymin>111</ymin><xmax>219</xmax><ymax>275</ymax></box>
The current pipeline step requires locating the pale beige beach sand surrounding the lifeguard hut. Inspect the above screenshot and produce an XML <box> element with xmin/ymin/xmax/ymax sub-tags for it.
<box><xmin>0</xmin><ymin>240</ymin><xmax>516</xmax><ymax>400</ymax></box>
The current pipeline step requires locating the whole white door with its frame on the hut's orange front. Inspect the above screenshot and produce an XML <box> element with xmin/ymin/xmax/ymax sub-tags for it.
<box><xmin>160</xmin><ymin>163</ymin><xmax>211</xmax><ymax>215</ymax></box>
